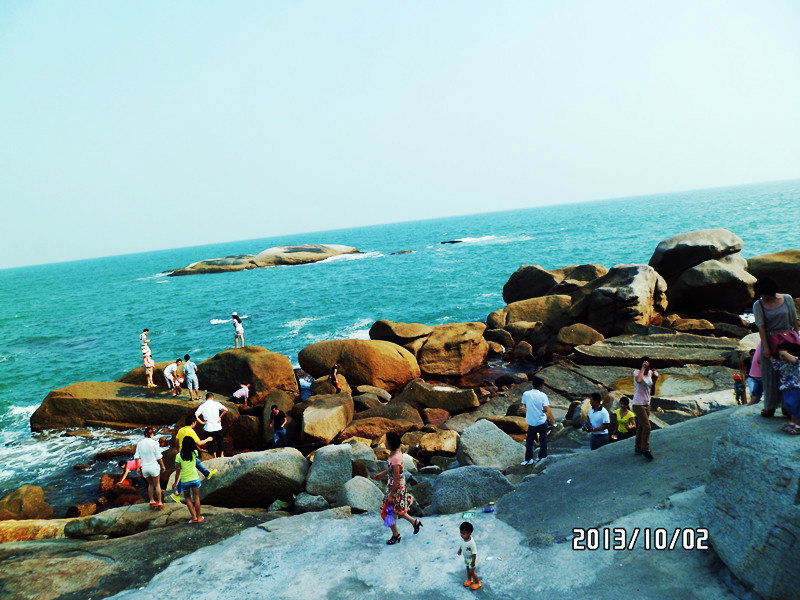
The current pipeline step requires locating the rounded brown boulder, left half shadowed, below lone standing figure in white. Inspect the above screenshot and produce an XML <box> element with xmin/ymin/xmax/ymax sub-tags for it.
<box><xmin>197</xmin><ymin>346</ymin><xmax>300</xmax><ymax>405</ymax></box>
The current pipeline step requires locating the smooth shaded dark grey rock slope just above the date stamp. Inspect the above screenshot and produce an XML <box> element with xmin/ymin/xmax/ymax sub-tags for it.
<box><xmin>497</xmin><ymin>408</ymin><xmax>737</xmax><ymax>541</ymax></box>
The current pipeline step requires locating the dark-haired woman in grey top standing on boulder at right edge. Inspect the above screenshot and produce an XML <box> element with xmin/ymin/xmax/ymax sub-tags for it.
<box><xmin>753</xmin><ymin>277</ymin><xmax>800</xmax><ymax>418</ymax></box>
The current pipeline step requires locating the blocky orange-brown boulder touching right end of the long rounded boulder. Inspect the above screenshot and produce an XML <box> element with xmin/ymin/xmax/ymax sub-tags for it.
<box><xmin>417</xmin><ymin>323</ymin><xmax>489</xmax><ymax>377</ymax></box>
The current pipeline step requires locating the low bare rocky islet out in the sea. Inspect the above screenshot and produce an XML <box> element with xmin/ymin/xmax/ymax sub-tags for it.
<box><xmin>170</xmin><ymin>244</ymin><xmax>360</xmax><ymax>277</ymax></box>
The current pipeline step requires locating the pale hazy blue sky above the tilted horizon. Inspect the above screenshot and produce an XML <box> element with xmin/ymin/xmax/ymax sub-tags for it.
<box><xmin>0</xmin><ymin>0</ymin><xmax>800</xmax><ymax>268</ymax></box>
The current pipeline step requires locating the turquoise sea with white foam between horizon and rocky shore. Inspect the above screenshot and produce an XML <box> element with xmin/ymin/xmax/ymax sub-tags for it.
<box><xmin>0</xmin><ymin>180</ymin><xmax>800</xmax><ymax>514</ymax></box>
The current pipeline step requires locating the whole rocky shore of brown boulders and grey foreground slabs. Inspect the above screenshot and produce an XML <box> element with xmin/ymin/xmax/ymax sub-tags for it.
<box><xmin>0</xmin><ymin>229</ymin><xmax>800</xmax><ymax>600</ymax></box>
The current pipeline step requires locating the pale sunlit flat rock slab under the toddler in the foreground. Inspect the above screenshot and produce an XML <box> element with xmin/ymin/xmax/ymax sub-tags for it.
<box><xmin>108</xmin><ymin>491</ymin><xmax>735</xmax><ymax>600</ymax></box>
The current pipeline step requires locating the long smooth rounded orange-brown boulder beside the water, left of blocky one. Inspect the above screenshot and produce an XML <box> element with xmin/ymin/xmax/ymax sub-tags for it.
<box><xmin>297</xmin><ymin>340</ymin><xmax>420</xmax><ymax>392</ymax></box>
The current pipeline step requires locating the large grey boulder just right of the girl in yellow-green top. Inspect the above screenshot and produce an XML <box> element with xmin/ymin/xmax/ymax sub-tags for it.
<box><xmin>188</xmin><ymin>448</ymin><xmax>308</xmax><ymax>508</ymax></box>
